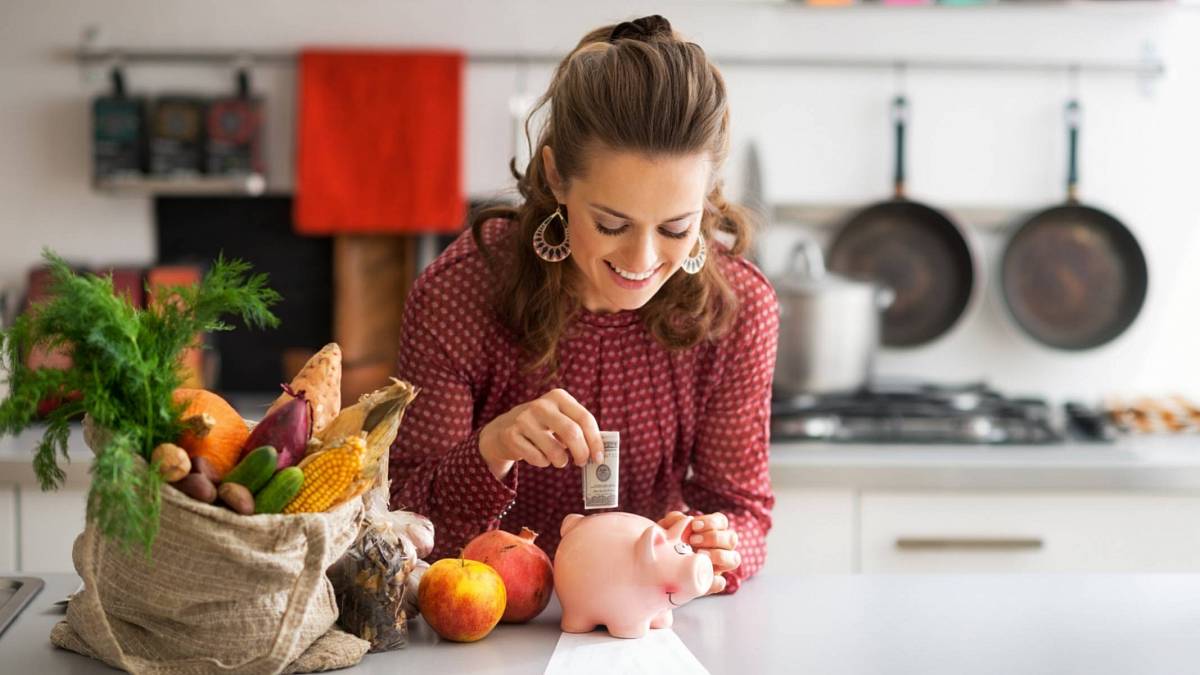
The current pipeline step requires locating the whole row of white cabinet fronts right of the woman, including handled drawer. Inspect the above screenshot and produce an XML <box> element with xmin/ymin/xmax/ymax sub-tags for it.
<box><xmin>767</xmin><ymin>486</ymin><xmax>1200</xmax><ymax>574</ymax></box>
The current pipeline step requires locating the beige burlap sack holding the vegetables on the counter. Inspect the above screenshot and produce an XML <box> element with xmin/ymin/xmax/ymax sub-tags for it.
<box><xmin>52</xmin><ymin>475</ymin><xmax>367</xmax><ymax>675</ymax></box>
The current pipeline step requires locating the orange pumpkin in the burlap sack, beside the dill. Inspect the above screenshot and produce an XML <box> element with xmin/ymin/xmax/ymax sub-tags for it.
<box><xmin>174</xmin><ymin>388</ymin><xmax>250</xmax><ymax>478</ymax></box>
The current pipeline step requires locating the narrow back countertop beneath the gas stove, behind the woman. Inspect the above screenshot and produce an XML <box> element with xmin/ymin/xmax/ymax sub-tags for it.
<box><xmin>7</xmin><ymin>425</ymin><xmax>1200</xmax><ymax>491</ymax></box>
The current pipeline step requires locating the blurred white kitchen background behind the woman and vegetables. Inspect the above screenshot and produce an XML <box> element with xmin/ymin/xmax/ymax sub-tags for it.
<box><xmin>0</xmin><ymin>0</ymin><xmax>1200</xmax><ymax>573</ymax></box>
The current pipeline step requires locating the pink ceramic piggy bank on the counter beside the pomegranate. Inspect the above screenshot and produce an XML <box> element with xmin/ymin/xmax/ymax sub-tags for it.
<box><xmin>554</xmin><ymin>512</ymin><xmax>713</xmax><ymax>638</ymax></box>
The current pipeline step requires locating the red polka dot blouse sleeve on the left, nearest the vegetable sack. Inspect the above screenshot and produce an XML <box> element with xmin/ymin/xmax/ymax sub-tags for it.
<box><xmin>389</xmin><ymin>273</ymin><xmax>517</xmax><ymax>560</ymax></box>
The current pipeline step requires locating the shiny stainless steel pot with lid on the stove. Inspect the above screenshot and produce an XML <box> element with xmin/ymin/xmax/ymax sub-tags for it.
<box><xmin>773</xmin><ymin>239</ymin><xmax>895</xmax><ymax>399</ymax></box>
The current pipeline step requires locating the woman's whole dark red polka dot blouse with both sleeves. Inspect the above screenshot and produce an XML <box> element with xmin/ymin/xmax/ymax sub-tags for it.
<box><xmin>390</xmin><ymin>219</ymin><xmax>779</xmax><ymax>592</ymax></box>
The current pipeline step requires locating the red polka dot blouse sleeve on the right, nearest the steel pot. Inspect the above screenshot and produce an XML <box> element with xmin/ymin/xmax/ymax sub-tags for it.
<box><xmin>683</xmin><ymin>265</ymin><xmax>779</xmax><ymax>593</ymax></box>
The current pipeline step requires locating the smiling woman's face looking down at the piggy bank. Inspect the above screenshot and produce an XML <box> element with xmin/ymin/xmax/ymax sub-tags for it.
<box><xmin>542</xmin><ymin>147</ymin><xmax>710</xmax><ymax>312</ymax></box>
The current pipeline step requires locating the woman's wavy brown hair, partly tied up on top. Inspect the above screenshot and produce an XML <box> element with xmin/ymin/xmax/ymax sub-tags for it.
<box><xmin>472</xmin><ymin>16</ymin><xmax>751</xmax><ymax>371</ymax></box>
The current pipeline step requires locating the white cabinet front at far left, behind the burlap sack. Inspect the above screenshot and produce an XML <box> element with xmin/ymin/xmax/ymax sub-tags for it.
<box><xmin>18</xmin><ymin>488</ymin><xmax>88</xmax><ymax>572</ymax></box>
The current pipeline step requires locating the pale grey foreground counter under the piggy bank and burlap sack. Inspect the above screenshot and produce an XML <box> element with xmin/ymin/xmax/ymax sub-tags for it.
<box><xmin>7</xmin><ymin>574</ymin><xmax>1200</xmax><ymax>675</ymax></box>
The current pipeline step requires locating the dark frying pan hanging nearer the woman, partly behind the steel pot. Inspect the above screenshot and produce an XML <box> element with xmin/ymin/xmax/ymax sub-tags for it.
<box><xmin>828</xmin><ymin>96</ymin><xmax>977</xmax><ymax>347</ymax></box>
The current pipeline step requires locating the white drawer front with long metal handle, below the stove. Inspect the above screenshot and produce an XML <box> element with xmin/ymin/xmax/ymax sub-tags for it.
<box><xmin>859</xmin><ymin>491</ymin><xmax>1200</xmax><ymax>573</ymax></box>
